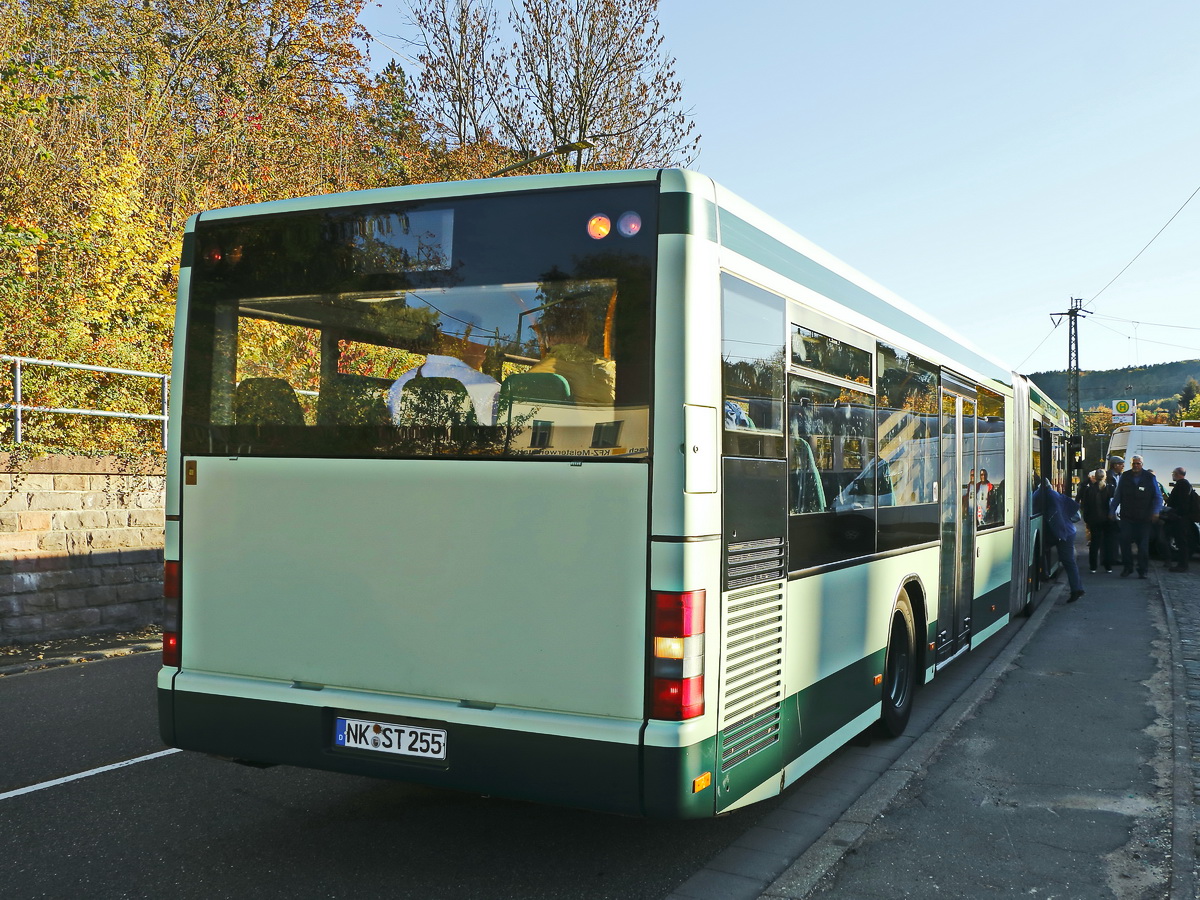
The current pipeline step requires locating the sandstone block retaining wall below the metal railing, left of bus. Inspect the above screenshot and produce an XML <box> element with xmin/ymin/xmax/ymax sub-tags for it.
<box><xmin>0</xmin><ymin>454</ymin><xmax>163</xmax><ymax>644</ymax></box>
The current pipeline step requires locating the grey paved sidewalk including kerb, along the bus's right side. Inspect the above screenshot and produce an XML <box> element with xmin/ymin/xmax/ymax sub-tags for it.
<box><xmin>762</xmin><ymin>553</ymin><xmax>1200</xmax><ymax>900</ymax></box>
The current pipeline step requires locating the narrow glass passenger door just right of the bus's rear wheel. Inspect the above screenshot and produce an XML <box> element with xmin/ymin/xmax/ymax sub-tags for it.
<box><xmin>937</xmin><ymin>388</ymin><xmax>976</xmax><ymax>664</ymax></box>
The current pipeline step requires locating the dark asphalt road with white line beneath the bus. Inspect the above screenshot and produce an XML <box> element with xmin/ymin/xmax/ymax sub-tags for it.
<box><xmin>0</xmin><ymin>620</ymin><xmax>1024</xmax><ymax>900</ymax></box>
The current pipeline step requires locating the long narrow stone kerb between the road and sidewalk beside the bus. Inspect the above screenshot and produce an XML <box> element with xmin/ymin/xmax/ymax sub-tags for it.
<box><xmin>760</xmin><ymin>583</ymin><xmax>1065</xmax><ymax>900</ymax></box>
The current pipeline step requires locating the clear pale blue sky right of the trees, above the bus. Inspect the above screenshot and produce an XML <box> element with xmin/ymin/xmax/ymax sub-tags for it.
<box><xmin>364</xmin><ymin>0</ymin><xmax>1200</xmax><ymax>372</ymax></box>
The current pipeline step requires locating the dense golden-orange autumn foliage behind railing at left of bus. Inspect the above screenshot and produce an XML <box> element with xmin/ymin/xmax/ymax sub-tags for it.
<box><xmin>0</xmin><ymin>0</ymin><xmax>391</xmax><ymax>451</ymax></box>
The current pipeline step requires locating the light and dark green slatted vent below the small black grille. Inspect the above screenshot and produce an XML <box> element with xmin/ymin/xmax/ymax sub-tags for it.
<box><xmin>721</xmin><ymin>582</ymin><xmax>784</xmax><ymax>772</ymax></box>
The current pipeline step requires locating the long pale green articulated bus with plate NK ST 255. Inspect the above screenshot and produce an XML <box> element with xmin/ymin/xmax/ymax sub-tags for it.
<box><xmin>157</xmin><ymin>170</ymin><xmax>1066</xmax><ymax>817</ymax></box>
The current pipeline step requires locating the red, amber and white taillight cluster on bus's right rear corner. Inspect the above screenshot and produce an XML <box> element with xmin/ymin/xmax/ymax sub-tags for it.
<box><xmin>650</xmin><ymin>590</ymin><xmax>704</xmax><ymax>721</ymax></box>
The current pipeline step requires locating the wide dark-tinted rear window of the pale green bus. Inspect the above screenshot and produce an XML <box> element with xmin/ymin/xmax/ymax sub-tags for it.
<box><xmin>184</xmin><ymin>186</ymin><xmax>656</xmax><ymax>458</ymax></box>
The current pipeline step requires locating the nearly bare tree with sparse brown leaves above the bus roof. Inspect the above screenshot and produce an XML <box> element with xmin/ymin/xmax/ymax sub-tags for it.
<box><xmin>409</xmin><ymin>0</ymin><xmax>698</xmax><ymax>170</ymax></box>
